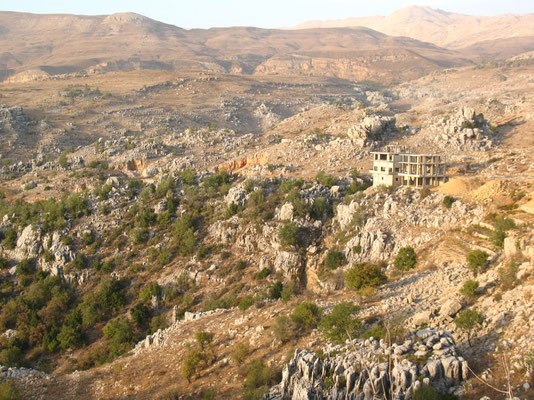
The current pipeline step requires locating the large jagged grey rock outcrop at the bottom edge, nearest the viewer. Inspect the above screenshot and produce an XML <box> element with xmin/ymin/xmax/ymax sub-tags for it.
<box><xmin>269</xmin><ymin>330</ymin><xmax>468</xmax><ymax>400</ymax></box>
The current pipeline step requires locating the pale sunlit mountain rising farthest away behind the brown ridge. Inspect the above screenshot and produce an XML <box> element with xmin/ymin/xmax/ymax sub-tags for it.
<box><xmin>291</xmin><ymin>6</ymin><xmax>534</xmax><ymax>57</ymax></box>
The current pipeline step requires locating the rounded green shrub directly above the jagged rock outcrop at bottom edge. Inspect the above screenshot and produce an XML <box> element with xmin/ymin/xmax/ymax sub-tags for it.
<box><xmin>319</xmin><ymin>302</ymin><xmax>362</xmax><ymax>343</ymax></box>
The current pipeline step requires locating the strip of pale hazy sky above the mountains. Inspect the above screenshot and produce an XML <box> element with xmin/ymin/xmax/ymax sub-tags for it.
<box><xmin>0</xmin><ymin>0</ymin><xmax>534</xmax><ymax>28</ymax></box>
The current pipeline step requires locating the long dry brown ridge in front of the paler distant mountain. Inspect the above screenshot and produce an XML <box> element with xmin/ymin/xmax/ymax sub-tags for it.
<box><xmin>0</xmin><ymin>12</ymin><xmax>468</xmax><ymax>81</ymax></box>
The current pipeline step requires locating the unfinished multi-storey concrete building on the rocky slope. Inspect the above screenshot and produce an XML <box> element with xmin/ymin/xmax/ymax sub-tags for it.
<box><xmin>370</xmin><ymin>145</ymin><xmax>447</xmax><ymax>188</ymax></box>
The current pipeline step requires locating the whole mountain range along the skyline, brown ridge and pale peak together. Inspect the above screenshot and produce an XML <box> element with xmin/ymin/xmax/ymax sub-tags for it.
<box><xmin>0</xmin><ymin>7</ymin><xmax>534</xmax><ymax>82</ymax></box>
